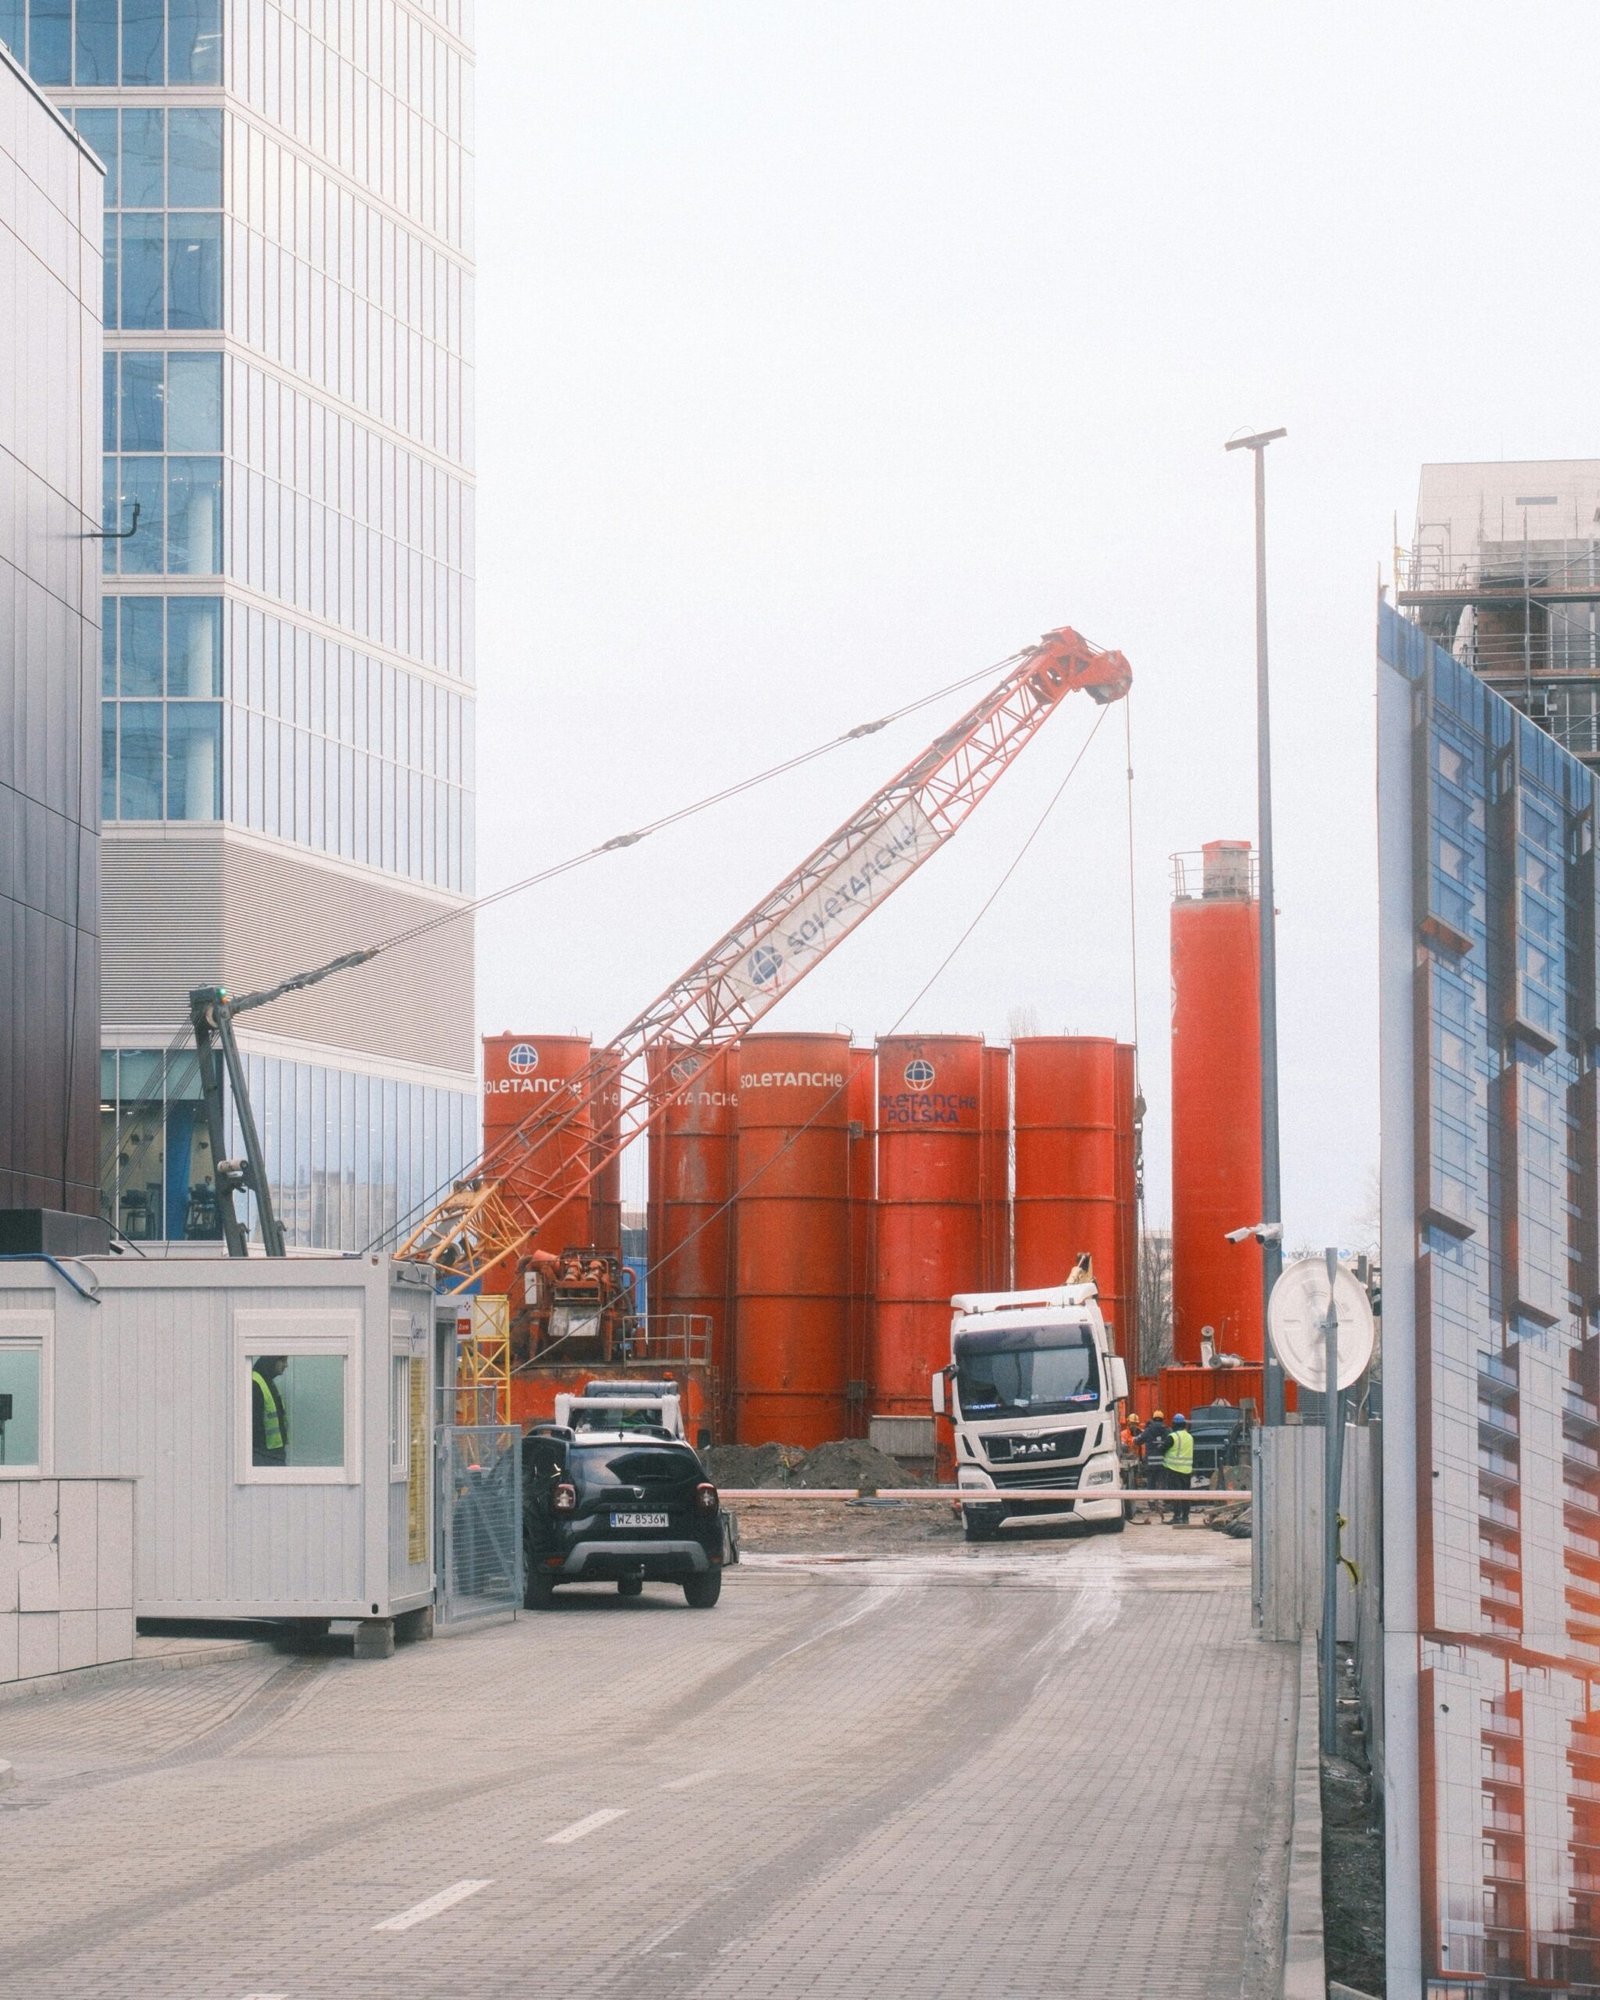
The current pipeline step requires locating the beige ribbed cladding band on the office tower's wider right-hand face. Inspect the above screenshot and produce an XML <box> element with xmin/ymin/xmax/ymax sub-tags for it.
<box><xmin>222</xmin><ymin>842</ymin><xmax>476</xmax><ymax>1070</ymax></box>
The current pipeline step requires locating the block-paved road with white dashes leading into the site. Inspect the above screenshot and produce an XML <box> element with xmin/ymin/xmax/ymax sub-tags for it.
<box><xmin>0</xmin><ymin>1528</ymin><xmax>1296</xmax><ymax>2000</ymax></box>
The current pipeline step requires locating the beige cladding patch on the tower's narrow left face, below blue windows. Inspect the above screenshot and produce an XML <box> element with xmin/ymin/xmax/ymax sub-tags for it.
<box><xmin>100</xmin><ymin>828</ymin><xmax>222</xmax><ymax>1034</ymax></box>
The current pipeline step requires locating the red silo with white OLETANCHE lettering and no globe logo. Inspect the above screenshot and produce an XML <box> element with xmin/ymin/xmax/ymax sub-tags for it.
<box><xmin>734</xmin><ymin>1034</ymin><xmax>852</xmax><ymax>1448</ymax></box>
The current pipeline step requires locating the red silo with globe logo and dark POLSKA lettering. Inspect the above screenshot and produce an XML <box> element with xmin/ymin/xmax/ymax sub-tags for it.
<box><xmin>872</xmin><ymin>1034</ymin><xmax>986</xmax><ymax>1416</ymax></box>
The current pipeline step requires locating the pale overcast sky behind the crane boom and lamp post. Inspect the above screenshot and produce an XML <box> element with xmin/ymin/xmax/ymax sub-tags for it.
<box><xmin>476</xmin><ymin>0</ymin><xmax>1600</xmax><ymax>1244</ymax></box>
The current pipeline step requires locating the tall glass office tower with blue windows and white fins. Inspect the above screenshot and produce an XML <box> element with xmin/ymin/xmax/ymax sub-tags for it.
<box><xmin>0</xmin><ymin>0</ymin><xmax>478</xmax><ymax>1248</ymax></box>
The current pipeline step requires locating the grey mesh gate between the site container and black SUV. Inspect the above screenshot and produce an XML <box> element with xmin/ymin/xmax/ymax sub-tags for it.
<box><xmin>434</xmin><ymin>1424</ymin><xmax>522</xmax><ymax>1626</ymax></box>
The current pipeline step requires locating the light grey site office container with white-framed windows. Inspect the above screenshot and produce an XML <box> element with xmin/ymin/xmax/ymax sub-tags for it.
<box><xmin>0</xmin><ymin>1254</ymin><xmax>436</xmax><ymax>1618</ymax></box>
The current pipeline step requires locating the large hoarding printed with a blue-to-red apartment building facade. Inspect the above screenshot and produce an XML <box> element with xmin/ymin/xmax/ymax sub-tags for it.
<box><xmin>1378</xmin><ymin>606</ymin><xmax>1600</xmax><ymax>2000</ymax></box>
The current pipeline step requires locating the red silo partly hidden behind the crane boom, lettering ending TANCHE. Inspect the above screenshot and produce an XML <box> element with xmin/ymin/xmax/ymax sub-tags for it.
<box><xmin>648</xmin><ymin>1048</ymin><xmax>738</xmax><ymax>1438</ymax></box>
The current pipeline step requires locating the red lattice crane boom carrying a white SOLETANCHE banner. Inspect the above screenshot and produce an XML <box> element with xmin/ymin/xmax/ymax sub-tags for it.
<box><xmin>396</xmin><ymin>628</ymin><xmax>1132</xmax><ymax>1336</ymax></box>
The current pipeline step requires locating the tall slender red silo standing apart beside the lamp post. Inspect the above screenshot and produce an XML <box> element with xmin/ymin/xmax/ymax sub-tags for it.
<box><xmin>1172</xmin><ymin>840</ymin><xmax>1262</xmax><ymax>1368</ymax></box>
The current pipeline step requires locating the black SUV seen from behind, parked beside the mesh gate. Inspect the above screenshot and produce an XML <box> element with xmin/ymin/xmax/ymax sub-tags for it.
<box><xmin>522</xmin><ymin>1424</ymin><xmax>724</xmax><ymax>1612</ymax></box>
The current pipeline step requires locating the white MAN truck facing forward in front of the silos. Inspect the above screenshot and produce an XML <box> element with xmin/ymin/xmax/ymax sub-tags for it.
<box><xmin>932</xmin><ymin>1278</ymin><xmax>1128</xmax><ymax>1542</ymax></box>
